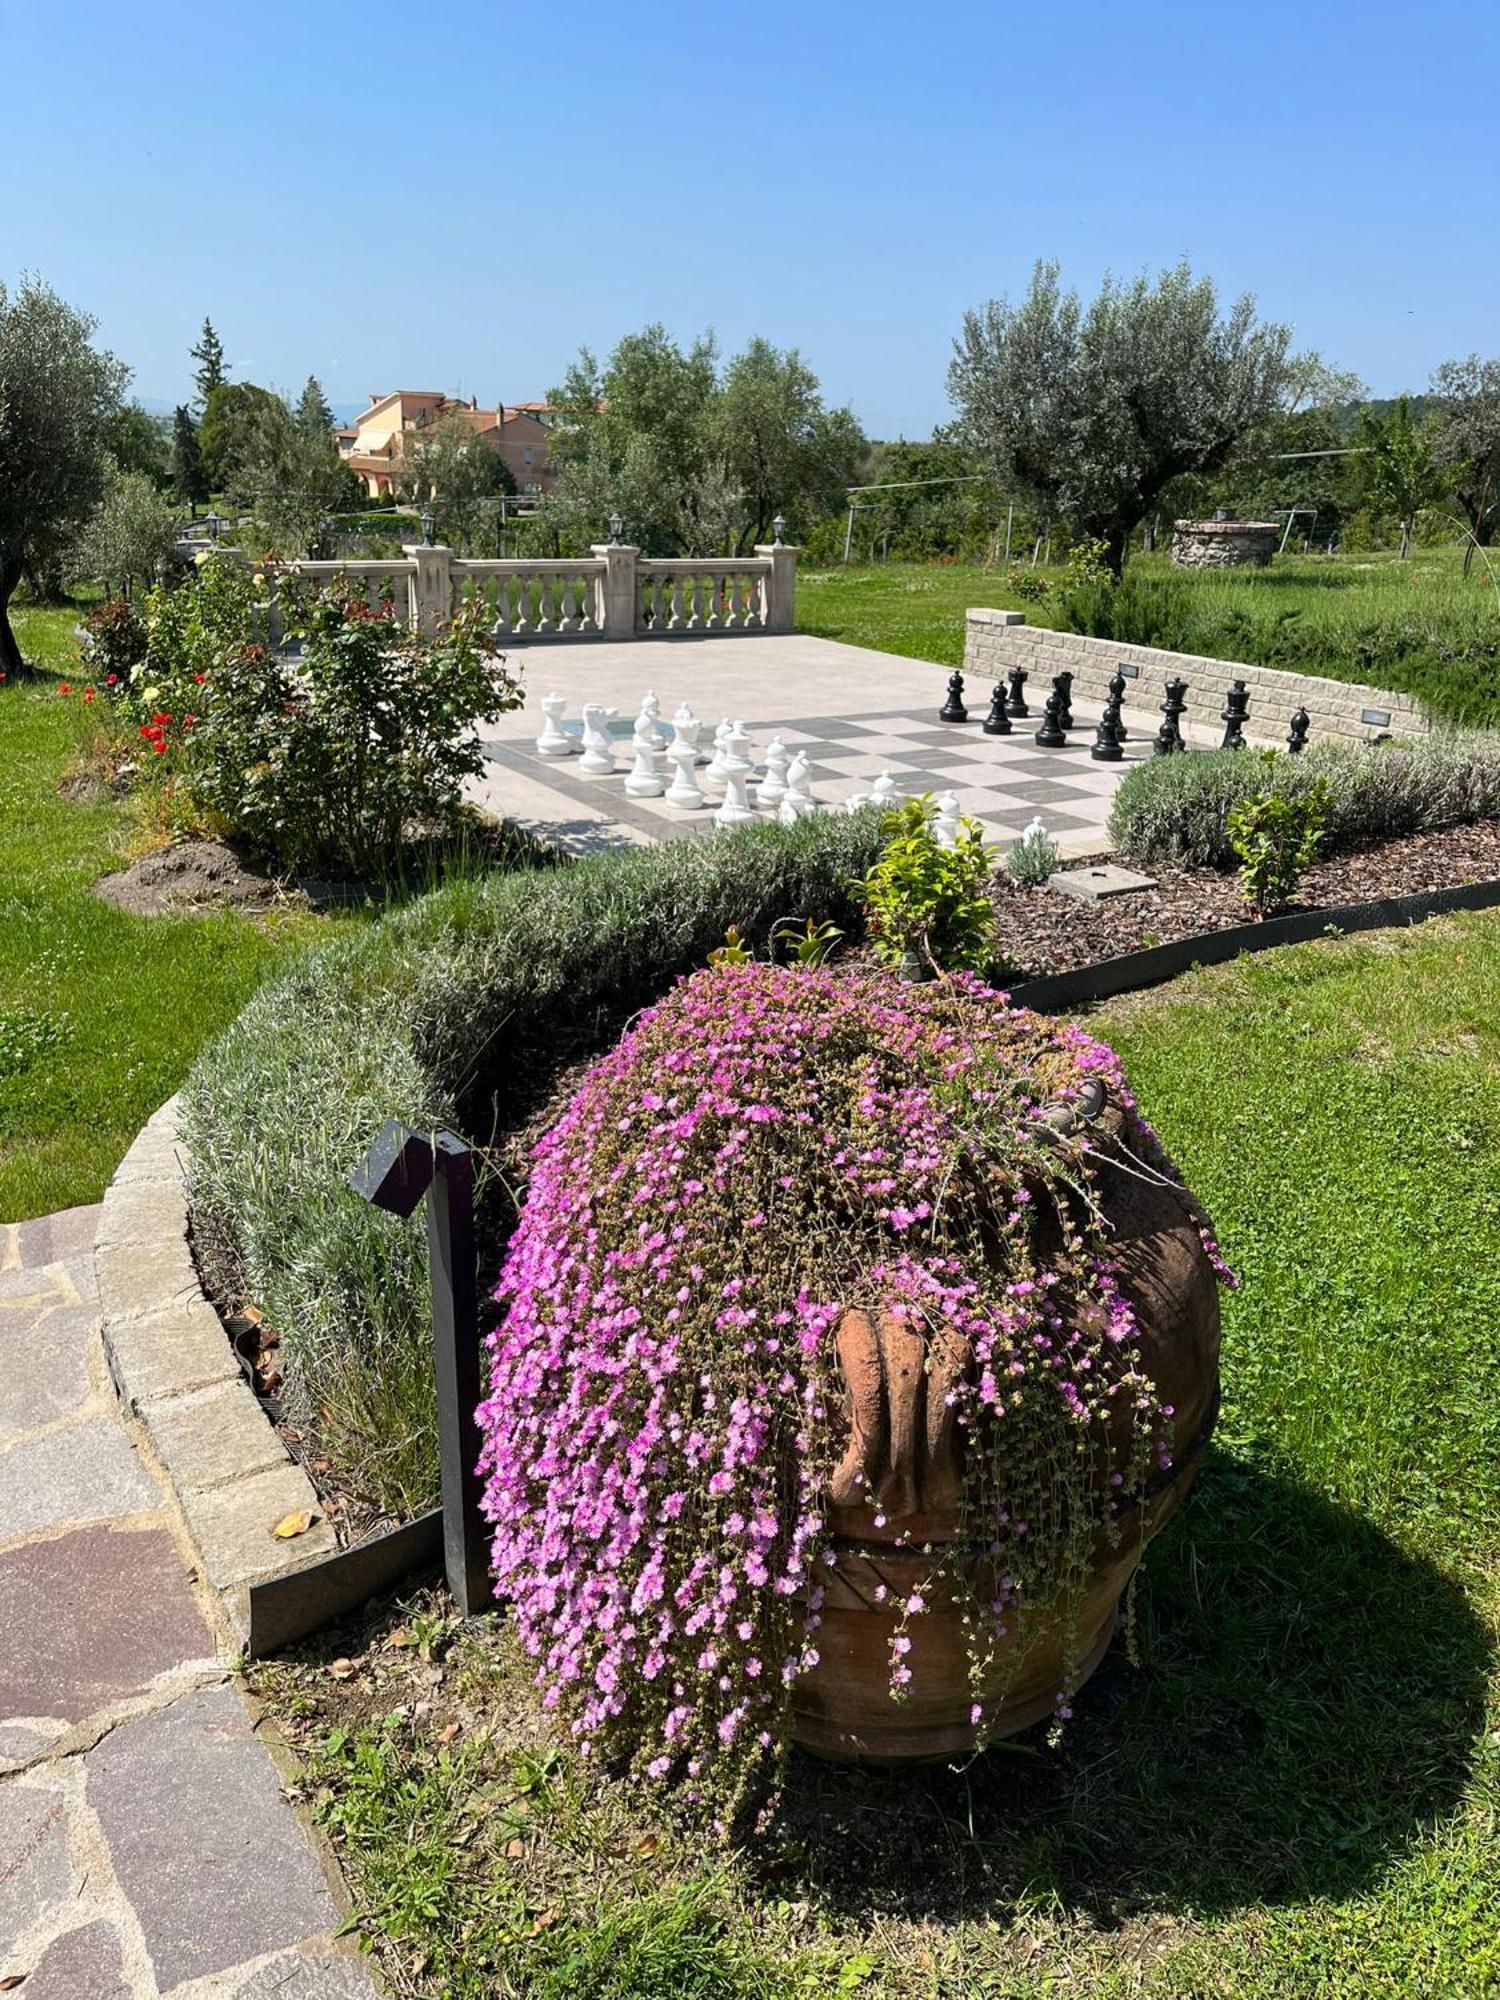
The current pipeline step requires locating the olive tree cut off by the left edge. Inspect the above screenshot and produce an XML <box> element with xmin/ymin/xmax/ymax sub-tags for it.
<box><xmin>0</xmin><ymin>278</ymin><xmax>130</xmax><ymax>674</ymax></box>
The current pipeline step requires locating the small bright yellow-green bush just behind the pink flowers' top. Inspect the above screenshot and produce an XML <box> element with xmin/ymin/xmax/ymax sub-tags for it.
<box><xmin>854</xmin><ymin>796</ymin><xmax>994</xmax><ymax>972</ymax></box>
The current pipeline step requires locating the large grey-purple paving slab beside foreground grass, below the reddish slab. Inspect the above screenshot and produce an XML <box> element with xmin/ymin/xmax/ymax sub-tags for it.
<box><xmin>84</xmin><ymin>1688</ymin><xmax>338</xmax><ymax>1992</ymax></box>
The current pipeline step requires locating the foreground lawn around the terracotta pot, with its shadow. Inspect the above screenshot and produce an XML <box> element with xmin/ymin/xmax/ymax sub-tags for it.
<box><xmin>268</xmin><ymin>914</ymin><xmax>1500</xmax><ymax>2000</ymax></box>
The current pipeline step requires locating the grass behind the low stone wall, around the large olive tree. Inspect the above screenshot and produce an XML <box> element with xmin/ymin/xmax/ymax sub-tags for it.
<box><xmin>796</xmin><ymin>548</ymin><xmax>1500</xmax><ymax>724</ymax></box>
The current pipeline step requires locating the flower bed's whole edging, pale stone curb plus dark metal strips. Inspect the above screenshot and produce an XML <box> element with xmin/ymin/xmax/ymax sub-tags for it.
<box><xmin>94</xmin><ymin>880</ymin><xmax>1500</xmax><ymax>1658</ymax></box>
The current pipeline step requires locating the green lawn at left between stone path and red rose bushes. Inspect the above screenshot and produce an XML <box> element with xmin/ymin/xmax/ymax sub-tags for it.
<box><xmin>0</xmin><ymin>610</ymin><xmax>330</xmax><ymax>1222</ymax></box>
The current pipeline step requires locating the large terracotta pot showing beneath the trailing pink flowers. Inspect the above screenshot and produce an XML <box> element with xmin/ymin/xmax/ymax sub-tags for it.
<box><xmin>792</xmin><ymin>1106</ymin><xmax>1220</xmax><ymax>1764</ymax></box>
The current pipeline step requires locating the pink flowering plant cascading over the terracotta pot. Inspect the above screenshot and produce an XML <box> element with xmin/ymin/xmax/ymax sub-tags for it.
<box><xmin>480</xmin><ymin>962</ymin><xmax>1232</xmax><ymax>1814</ymax></box>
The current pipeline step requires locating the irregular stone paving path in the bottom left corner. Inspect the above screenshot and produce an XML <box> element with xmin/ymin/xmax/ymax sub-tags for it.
<box><xmin>0</xmin><ymin>1208</ymin><xmax>378</xmax><ymax>2000</ymax></box>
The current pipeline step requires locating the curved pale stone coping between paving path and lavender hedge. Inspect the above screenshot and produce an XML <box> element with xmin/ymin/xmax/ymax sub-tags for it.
<box><xmin>94</xmin><ymin>1098</ymin><xmax>338</xmax><ymax>1646</ymax></box>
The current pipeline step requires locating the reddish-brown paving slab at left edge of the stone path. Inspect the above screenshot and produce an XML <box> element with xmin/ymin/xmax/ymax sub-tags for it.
<box><xmin>0</xmin><ymin>1528</ymin><xmax>214</xmax><ymax>1722</ymax></box>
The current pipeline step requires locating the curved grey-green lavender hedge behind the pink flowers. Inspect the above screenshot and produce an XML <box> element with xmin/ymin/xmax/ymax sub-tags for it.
<box><xmin>184</xmin><ymin>812</ymin><xmax>880</xmax><ymax>1516</ymax></box>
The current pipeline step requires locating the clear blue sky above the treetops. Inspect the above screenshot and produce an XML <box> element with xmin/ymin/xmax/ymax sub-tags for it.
<box><xmin>0</xmin><ymin>0</ymin><xmax>1500</xmax><ymax>436</ymax></box>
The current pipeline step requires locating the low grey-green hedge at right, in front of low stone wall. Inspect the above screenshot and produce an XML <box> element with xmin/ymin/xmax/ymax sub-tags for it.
<box><xmin>1110</xmin><ymin>730</ymin><xmax>1500</xmax><ymax>868</ymax></box>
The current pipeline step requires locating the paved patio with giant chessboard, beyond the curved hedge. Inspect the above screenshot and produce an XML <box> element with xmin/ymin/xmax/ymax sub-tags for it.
<box><xmin>470</xmin><ymin>634</ymin><xmax>1216</xmax><ymax>856</ymax></box>
